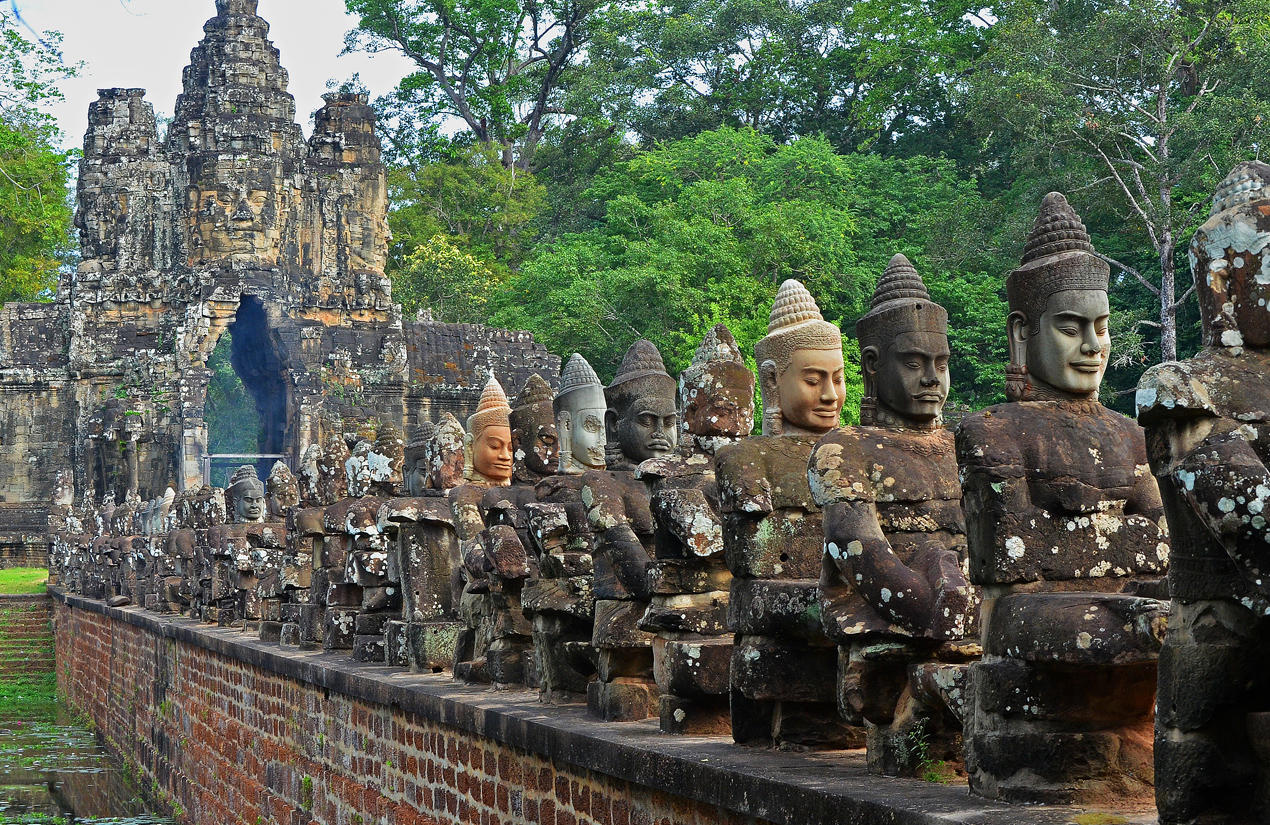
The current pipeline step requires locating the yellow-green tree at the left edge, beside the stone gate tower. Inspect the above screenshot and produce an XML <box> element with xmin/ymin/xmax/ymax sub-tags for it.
<box><xmin>0</xmin><ymin>11</ymin><xmax>76</xmax><ymax>303</ymax></box>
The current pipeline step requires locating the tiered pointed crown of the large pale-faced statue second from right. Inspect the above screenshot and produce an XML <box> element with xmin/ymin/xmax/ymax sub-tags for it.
<box><xmin>1006</xmin><ymin>192</ymin><xmax>1111</xmax><ymax>322</ymax></box>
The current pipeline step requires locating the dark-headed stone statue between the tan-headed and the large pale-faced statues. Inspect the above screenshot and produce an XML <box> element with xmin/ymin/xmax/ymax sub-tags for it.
<box><xmin>810</xmin><ymin>255</ymin><xmax>978</xmax><ymax>776</ymax></box>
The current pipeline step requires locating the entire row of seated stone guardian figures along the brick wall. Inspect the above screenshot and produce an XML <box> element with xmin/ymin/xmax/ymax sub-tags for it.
<box><xmin>51</xmin><ymin>162</ymin><xmax>1270</xmax><ymax>824</ymax></box>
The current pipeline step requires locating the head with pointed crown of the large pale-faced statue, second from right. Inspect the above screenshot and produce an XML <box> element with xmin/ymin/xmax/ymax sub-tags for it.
<box><xmin>1006</xmin><ymin>192</ymin><xmax>1111</xmax><ymax>401</ymax></box>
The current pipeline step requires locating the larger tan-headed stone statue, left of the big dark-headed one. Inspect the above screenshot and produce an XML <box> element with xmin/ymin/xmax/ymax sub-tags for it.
<box><xmin>715</xmin><ymin>281</ymin><xmax>852</xmax><ymax>748</ymax></box>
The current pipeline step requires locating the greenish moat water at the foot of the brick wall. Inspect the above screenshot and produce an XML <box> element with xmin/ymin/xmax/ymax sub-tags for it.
<box><xmin>0</xmin><ymin>703</ymin><xmax>173</xmax><ymax>825</ymax></box>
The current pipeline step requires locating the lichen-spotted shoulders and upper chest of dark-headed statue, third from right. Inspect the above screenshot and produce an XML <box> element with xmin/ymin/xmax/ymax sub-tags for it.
<box><xmin>808</xmin><ymin>426</ymin><xmax>961</xmax><ymax>506</ymax></box>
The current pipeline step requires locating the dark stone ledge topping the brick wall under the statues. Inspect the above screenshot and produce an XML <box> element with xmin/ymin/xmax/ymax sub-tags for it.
<box><xmin>54</xmin><ymin>588</ymin><xmax>1156</xmax><ymax>825</ymax></box>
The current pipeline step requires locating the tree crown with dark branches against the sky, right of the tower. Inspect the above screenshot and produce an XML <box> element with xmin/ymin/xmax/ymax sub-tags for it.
<box><xmin>345</xmin><ymin>0</ymin><xmax>599</xmax><ymax>168</ymax></box>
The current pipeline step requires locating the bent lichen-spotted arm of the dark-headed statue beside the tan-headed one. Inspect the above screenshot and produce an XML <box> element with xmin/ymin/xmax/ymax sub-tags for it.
<box><xmin>824</xmin><ymin>501</ymin><xmax>936</xmax><ymax>635</ymax></box>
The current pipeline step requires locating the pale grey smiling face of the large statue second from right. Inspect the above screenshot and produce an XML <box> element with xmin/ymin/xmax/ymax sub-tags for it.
<box><xmin>1011</xmin><ymin>289</ymin><xmax>1111</xmax><ymax>396</ymax></box>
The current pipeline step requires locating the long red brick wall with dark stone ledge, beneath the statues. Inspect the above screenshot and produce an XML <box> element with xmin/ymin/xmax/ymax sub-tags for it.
<box><xmin>53</xmin><ymin>590</ymin><xmax>1127</xmax><ymax>825</ymax></box>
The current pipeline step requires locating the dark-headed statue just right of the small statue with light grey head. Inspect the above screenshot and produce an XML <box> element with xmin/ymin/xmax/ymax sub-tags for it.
<box><xmin>582</xmin><ymin>340</ymin><xmax>679</xmax><ymax>721</ymax></box>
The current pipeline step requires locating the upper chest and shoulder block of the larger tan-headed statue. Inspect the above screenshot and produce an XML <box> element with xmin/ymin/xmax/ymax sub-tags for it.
<box><xmin>715</xmin><ymin>435</ymin><xmax>819</xmax><ymax>513</ymax></box>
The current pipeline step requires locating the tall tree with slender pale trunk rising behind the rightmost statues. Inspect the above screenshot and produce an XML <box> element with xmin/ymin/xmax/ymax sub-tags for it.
<box><xmin>966</xmin><ymin>0</ymin><xmax>1270</xmax><ymax>360</ymax></box>
